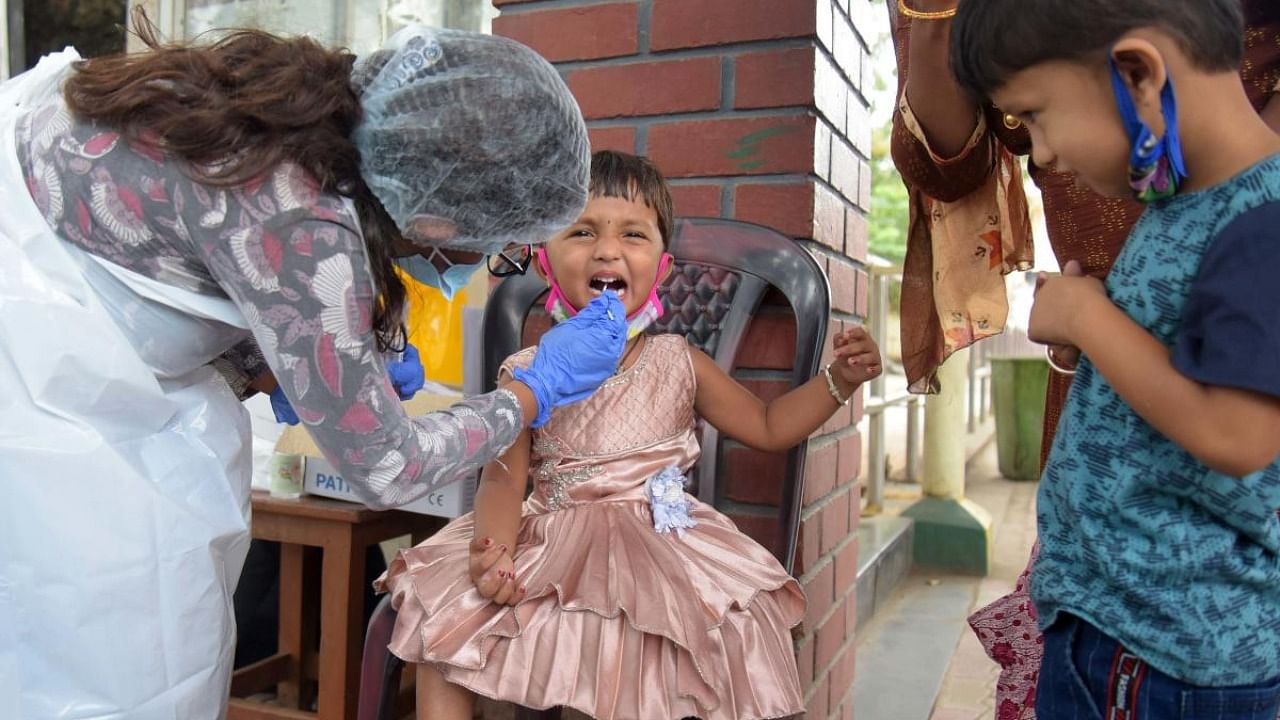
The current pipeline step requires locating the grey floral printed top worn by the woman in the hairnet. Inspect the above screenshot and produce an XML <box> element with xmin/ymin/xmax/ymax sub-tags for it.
<box><xmin>17</xmin><ymin>99</ymin><xmax>522</xmax><ymax>507</ymax></box>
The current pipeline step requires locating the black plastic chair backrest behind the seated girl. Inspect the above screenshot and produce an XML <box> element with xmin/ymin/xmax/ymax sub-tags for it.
<box><xmin>484</xmin><ymin>218</ymin><xmax>831</xmax><ymax>571</ymax></box>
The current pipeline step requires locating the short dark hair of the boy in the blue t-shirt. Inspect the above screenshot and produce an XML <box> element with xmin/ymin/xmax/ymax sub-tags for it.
<box><xmin>951</xmin><ymin>0</ymin><xmax>1244</xmax><ymax>97</ymax></box>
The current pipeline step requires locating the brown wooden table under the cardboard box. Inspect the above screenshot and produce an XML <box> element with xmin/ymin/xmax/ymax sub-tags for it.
<box><xmin>227</xmin><ymin>491</ymin><xmax>448</xmax><ymax>720</ymax></box>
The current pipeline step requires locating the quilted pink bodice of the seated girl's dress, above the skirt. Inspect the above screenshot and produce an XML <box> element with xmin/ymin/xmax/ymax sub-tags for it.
<box><xmin>503</xmin><ymin>334</ymin><xmax>699</xmax><ymax>510</ymax></box>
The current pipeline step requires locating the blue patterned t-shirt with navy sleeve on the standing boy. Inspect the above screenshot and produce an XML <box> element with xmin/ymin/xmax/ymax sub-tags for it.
<box><xmin>1030</xmin><ymin>155</ymin><xmax>1280</xmax><ymax>687</ymax></box>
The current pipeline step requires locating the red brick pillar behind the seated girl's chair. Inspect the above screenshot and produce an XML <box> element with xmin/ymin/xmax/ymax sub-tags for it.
<box><xmin>493</xmin><ymin>0</ymin><xmax>874</xmax><ymax>720</ymax></box>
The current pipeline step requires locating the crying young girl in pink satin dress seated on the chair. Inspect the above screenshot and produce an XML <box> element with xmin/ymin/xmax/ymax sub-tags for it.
<box><xmin>381</xmin><ymin>152</ymin><xmax>881</xmax><ymax>720</ymax></box>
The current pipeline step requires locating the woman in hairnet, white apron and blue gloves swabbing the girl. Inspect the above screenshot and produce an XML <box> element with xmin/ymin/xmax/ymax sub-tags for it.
<box><xmin>0</xmin><ymin>17</ymin><xmax>626</xmax><ymax>720</ymax></box>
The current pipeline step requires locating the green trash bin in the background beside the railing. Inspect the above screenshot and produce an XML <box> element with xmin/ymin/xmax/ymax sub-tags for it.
<box><xmin>991</xmin><ymin>355</ymin><xmax>1048</xmax><ymax>480</ymax></box>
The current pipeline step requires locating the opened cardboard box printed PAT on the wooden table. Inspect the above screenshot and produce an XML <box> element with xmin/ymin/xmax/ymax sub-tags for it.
<box><xmin>275</xmin><ymin>391</ymin><xmax>480</xmax><ymax>518</ymax></box>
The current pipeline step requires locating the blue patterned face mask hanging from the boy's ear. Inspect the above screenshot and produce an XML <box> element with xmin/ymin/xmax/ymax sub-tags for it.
<box><xmin>1108</xmin><ymin>58</ymin><xmax>1187</xmax><ymax>202</ymax></box>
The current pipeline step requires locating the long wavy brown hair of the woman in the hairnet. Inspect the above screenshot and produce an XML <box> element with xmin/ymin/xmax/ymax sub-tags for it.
<box><xmin>64</xmin><ymin>9</ymin><xmax>404</xmax><ymax>351</ymax></box>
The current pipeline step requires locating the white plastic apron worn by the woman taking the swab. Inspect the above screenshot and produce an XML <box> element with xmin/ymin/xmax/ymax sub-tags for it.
<box><xmin>0</xmin><ymin>50</ymin><xmax>251</xmax><ymax>720</ymax></box>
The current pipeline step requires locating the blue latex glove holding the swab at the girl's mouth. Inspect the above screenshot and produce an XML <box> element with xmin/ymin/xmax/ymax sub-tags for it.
<box><xmin>513</xmin><ymin>291</ymin><xmax>627</xmax><ymax>428</ymax></box>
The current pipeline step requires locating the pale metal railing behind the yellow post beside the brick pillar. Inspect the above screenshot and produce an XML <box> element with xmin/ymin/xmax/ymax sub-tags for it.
<box><xmin>863</xmin><ymin>258</ymin><xmax>992</xmax><ymax>516</ymax></box>
